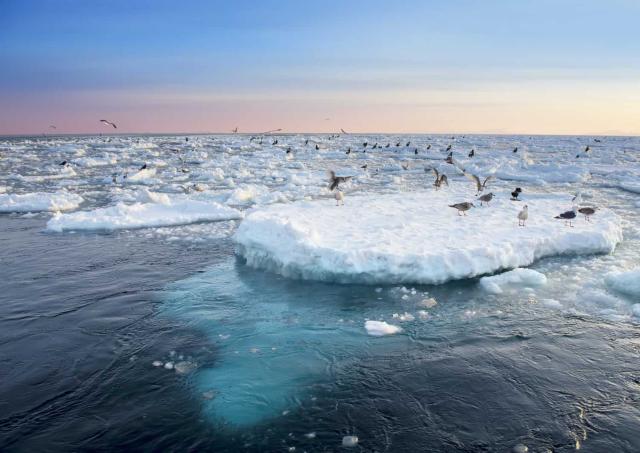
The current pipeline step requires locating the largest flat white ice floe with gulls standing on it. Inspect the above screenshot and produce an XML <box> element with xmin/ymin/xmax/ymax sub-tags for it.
<box><xmin>235</xmin><ymin>189</ymin><xmax>622</xmax><ymax>284</ymax></box>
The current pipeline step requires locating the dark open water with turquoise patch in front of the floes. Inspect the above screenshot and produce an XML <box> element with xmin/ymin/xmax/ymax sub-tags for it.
<box><xmin>0</xmin><ymin>215</ymin><xmax>640</xmax><ymax>452</ymax></box>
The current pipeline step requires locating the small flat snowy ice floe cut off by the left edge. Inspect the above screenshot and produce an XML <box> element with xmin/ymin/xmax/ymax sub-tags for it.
<box><xmin>0</xmin><ymin>191</ymin><xmax>84</xmax><ymax>212</ymax></box>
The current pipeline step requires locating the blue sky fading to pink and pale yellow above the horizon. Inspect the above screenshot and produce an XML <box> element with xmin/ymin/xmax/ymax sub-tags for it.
<box><xmin>0</xmin><ymin>0</ymin><xmax>640</xmax><ymax>135</ymax></box>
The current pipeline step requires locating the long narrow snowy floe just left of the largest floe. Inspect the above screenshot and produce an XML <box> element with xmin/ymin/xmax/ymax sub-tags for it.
<box><xmin>47</xmin><ymin>200</ymin><xmax>242</xmax><ymax>232</ymax></box>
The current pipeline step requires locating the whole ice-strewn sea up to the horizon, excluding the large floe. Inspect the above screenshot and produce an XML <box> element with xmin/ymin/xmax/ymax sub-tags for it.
<box><xmin>0</xmin><ymin>135</ymin><xmax>640</xmax><ymax>452</ymax></box>
